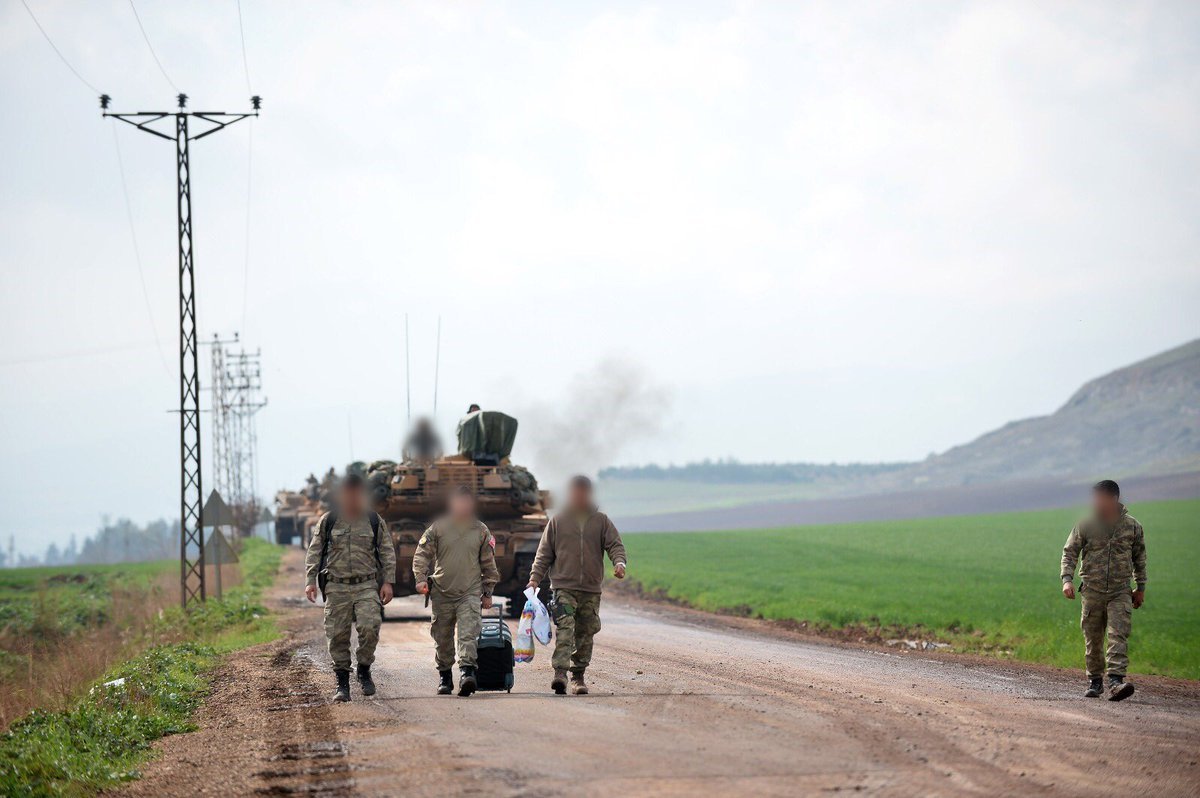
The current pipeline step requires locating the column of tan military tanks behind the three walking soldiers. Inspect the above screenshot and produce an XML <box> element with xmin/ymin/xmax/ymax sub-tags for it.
<box><xmin>275</xmin><ymin>410</ymin><xmax>550</xmax><ymax>614</ymax></box>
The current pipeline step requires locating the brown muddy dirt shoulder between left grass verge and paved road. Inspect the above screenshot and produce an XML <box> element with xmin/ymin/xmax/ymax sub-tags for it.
<box><xmin>110</xmin><ymin>548</ymin><xmax>352</xmax><ymax>797</ymax></box>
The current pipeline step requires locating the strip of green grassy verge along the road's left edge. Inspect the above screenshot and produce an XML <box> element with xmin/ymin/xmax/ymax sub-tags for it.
<box><xmin>0</xmin><ymin>540</ymin><xmax>282</xmax><ymax>796</ymax></box>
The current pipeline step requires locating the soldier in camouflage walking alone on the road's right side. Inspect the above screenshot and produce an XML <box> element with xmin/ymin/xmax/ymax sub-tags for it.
<box><xmin>1061</xmin><ymin>479</ymin><xmax>1146</xmax><ymax>701</ymax></box>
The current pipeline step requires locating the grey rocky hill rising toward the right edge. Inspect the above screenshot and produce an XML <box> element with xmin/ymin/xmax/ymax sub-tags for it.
<box><xmin>887</xmin><ymin>340</ymin><xmax>1200</xmax><ymax>488</ymax></box>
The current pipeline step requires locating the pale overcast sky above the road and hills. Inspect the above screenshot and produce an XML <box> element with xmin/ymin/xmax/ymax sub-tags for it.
<box><xmin>0</xmin><ymin>0</ymin><xmax>1200</xmax><ymax>551</ymax></box>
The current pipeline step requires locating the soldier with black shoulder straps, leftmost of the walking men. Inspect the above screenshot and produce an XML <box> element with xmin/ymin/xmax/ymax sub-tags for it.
<box><xmin>304</xmin><ymin>474</ymin><xmax>396</xmax><ymax>701</ymax></box>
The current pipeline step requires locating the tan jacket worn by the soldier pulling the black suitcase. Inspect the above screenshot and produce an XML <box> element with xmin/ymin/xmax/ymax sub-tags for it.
<box><xmin>413</xmin><ymin>517</ymin><xmax>500</xmax><ymax>598</ymax></box>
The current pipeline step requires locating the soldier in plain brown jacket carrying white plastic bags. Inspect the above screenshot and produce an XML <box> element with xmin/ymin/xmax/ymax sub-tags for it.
<box><xmin>528</xmin><ymin>475</ymin><xmax>626</xmax><ymax>696</ymax></box>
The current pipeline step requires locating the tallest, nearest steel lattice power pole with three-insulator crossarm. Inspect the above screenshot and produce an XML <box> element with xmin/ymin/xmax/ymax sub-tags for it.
<box><xmin>100</xmin><ymin>94</ymin><xmax>262</xmax><ymax>608</ymax></box>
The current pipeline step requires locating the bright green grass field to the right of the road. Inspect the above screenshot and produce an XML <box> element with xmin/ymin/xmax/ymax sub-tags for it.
<box><xmin>625</xmin><ymin>500</ymin><xmax>1200</xmax><ymax>679</ymax></box>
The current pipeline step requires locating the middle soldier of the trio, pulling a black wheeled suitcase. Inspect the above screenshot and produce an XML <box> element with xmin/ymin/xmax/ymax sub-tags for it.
<box><xmin>413</xmin><ymin>485</ymin><xmax>500</xmax><ymax>696</ymax></box>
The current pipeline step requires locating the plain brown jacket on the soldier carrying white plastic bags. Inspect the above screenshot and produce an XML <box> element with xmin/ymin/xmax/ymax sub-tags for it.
<box><xmin>529</xmin><ymin>511</ymin><xmax>626</xmax><ymax>593</ymax></box>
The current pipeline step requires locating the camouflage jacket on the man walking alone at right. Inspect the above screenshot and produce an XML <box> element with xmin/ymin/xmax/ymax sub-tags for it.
<box><xmin>1061</xmin><ymin>505</ymin><xmax>1146</xmax><ymax>593</ymax></box>
